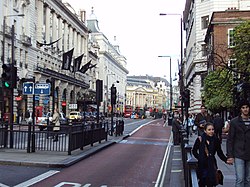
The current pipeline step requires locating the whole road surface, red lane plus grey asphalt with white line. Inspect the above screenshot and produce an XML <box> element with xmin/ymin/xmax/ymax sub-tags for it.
<box><xmin>0</xmin><ymin>119</ymin><xmax>170</xmax><ymax>187</ymax></box>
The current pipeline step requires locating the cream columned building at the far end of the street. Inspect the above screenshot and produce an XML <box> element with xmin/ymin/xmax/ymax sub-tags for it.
<box><xmin>126</xmin><ymin>75</ymin><xmax>179</xmax><ymax>110</ymax></box>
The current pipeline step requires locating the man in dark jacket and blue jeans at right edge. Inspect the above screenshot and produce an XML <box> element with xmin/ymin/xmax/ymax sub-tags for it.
<box><xmin>227</xmin><ymin>100</ymin><xmax>250</xmax><ymax>187</ymax></box>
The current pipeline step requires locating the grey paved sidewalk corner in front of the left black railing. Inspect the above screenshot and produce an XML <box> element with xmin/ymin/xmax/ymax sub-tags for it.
<box><xmin>0</xmin><ymin>135</ymin><xmax>126</xmax><ymax>168</ymax></box>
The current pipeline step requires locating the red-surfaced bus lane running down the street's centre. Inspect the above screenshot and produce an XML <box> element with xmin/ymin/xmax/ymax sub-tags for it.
<box><xmin>34</xmin><ymin>122</ymin><xmax>171</xmax><ymax>187</ymax></box>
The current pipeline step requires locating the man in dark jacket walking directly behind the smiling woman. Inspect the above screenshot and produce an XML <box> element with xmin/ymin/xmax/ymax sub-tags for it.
<box><xmin>194</xmin><ymin>105</ymin><xmax>212</xmax><ymax>136</ymax></box>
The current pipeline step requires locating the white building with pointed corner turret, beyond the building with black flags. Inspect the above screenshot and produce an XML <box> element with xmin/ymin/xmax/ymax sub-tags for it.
<box><xmin>87</xmin><ymin>9</ymin><xmax>129</xmax><ymax>113</ymax></box>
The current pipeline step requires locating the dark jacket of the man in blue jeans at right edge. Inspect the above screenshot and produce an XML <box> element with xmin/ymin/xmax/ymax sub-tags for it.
<box><xmin>227</xmin><ymin>116</ymin><xmax>250</xmax><ymax>160</ymax></box>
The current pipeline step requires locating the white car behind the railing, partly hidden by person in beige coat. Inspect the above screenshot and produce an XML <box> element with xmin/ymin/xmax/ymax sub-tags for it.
<box><xmin>36</xmin><ymin>112</ymin><xmax>68</xmax><ymax>131</ymax></box>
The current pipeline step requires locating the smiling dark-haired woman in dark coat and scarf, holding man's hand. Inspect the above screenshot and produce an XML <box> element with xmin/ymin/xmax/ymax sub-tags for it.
<box><xmin>192</xmin><ymin>122</ymin><xmax>227</xmax><ymax>187</ymax></box>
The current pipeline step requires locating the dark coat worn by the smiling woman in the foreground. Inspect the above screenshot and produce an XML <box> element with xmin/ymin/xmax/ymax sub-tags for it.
<box><xmin>192</xmin><ymin>133</ymin><xmax>227</xmax><ymax>185</ymax></box>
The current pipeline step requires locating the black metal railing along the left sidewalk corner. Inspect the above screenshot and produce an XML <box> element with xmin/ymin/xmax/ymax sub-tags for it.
<box><xmin>0</xmin><ymin>121</ymin><xmax>124</xmax><ymax>155</ymax></box>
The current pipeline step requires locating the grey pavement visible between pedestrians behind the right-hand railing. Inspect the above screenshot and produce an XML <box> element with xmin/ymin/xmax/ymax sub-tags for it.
<box><xmin>189</xmin><ymin>134</ymin><xmax>235</xmax><ymax>187</ymax></box>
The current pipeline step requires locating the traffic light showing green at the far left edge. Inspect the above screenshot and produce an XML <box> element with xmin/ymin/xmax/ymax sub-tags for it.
<box><xmin>2</xmin><ymin>64</ymin><xmax>17</xmax><ymax>89</ymax></box>
